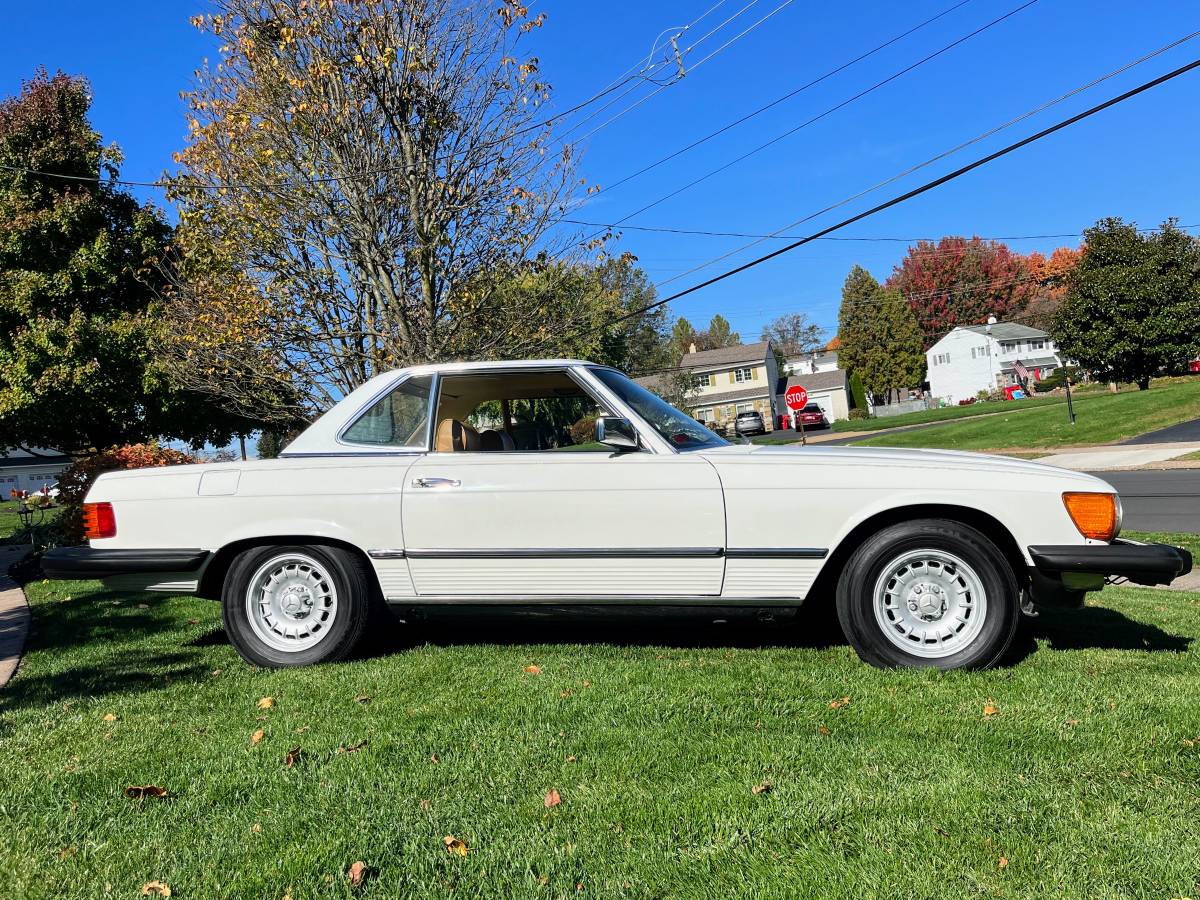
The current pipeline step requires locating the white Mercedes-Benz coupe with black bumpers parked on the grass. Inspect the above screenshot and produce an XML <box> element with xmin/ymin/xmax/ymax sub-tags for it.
<box><xmin>42</xmin><ymin>360</ymin><xmax>1192</xmax><ymax>668</ymax></box>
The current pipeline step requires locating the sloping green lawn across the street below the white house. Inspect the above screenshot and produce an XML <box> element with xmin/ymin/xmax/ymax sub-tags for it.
<box><xmin>857</xmin><ymin>379</ymin><xmax>1200</xmax><ymax>450</ymax></box>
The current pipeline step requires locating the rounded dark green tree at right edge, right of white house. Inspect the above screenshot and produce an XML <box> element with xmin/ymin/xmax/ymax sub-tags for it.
<box><xmin>1052</xmin><ymin>218</ymin><xmax>1200</xmax><ymax>390</ymax></box>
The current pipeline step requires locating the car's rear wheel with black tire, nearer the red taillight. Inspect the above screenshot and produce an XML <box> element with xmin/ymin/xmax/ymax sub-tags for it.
<box><xmin>221</xmin><ymin>545</ymin><xmax>373</xmax><ymax>667</ymax></box>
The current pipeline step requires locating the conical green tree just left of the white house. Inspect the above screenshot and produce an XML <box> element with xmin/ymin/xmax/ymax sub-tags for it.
<box><xmin>838</xmin><ymin>265</ymin><xmax>925</xmax><ymax>400</ymax></box>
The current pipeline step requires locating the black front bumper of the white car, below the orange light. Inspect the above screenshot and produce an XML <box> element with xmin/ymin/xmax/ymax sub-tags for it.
<box><xmin>1030</xmin><ymin>540</ymin><xmax>1192</xmax><ymax>606</ymax></box>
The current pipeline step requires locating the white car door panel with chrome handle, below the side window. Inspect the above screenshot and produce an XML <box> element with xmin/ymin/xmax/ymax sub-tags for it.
<box><xmin>401</xmin><ymin>369</ymin><xmax>725</xmax><ymax>602</ymax></box>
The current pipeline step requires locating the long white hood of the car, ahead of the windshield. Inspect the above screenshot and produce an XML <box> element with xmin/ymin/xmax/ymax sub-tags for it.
<box><xmin>702</xmin><ymin>444</ymin><xmax>1116</xmax><ymax>493</ymax></box>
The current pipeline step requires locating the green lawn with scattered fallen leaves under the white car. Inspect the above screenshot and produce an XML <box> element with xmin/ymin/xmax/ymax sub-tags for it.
<box><xmin>0</xmin><ymin>564</ymin><xmax>1200</xmax><ymax>900</ymax></box>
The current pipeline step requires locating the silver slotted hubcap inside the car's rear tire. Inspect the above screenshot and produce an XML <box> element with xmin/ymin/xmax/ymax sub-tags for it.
<box><xmin>246</xmin><ymin>553</ymin><xmax>337</xmax><ymax>653</ymax></box>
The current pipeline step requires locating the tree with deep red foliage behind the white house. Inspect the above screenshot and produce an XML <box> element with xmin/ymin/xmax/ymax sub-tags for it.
<box><xmin>884</xmin><ymin>236</ymin><xmax>1038</xmax><ymax>348</ymax></box>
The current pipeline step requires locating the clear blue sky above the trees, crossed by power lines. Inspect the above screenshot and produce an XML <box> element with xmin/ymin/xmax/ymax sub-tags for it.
<box><xmin>7</xmin><ymin>0</ymin><xmax>1200</xmax><ymax>348</ymax></box>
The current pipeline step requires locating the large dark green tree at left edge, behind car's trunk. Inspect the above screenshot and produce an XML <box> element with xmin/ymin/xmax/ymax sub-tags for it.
<box><xmin>0</xmin><ymin>71</ymin><xmax>256</xmax><ymax>454</ymax></box>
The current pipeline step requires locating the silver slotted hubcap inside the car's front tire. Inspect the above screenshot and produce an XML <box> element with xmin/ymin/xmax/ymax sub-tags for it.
<box><xmin>872</xmin><ymin>550</ymin><xmax>988</xmax><ymax>659</ymax></box>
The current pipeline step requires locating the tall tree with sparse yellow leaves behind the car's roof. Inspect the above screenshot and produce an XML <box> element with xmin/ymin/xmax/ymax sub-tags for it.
<box><xmin>164</xmin><ymin>0</ymin><xmax>594</xmax><ymax>420</ymax></box>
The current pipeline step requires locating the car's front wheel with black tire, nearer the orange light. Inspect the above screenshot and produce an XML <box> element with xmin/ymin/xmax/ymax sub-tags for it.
<box><xmin>838</xmin><ymin>518</ymin><xmax>1020</xmax><ymax>670</ymax></box>
